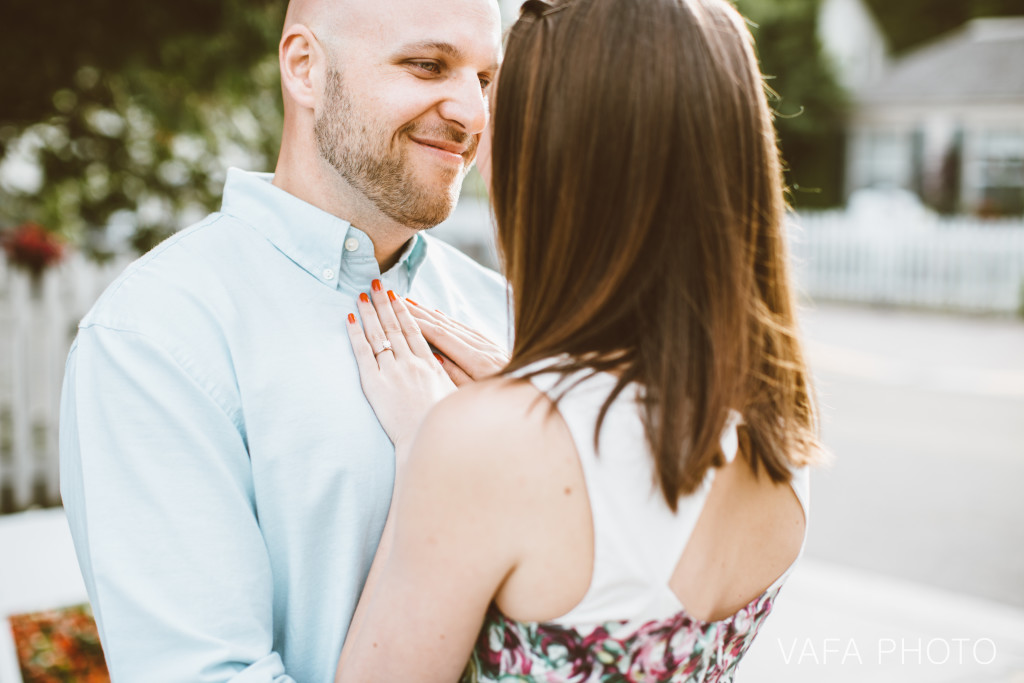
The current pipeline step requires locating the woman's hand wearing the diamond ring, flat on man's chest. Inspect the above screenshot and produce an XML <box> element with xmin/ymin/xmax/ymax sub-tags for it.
<box><xmin>348</xmin><ymin>280</ymin><xmax>456</xmax><ymax>452</ymax></box>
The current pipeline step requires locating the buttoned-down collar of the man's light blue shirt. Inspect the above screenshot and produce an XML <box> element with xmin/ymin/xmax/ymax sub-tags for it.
<box><xmin>221</xmin><ymin>168</ymin><xmax>427</xmax><ymax>289</ymax></box>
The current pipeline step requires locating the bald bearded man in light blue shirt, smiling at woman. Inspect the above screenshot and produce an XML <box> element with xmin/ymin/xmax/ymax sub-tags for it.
<box><xmin>60</xmin><ymin>0</ymin><xmax>507</xmax><ymax>683</ymax></box>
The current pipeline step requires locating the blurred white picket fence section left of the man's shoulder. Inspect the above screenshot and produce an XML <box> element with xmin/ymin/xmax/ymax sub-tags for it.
<box><xmin>0</xmin><ymin>253</ymin><xmax>125</xmax><ymax>512</ymax></box>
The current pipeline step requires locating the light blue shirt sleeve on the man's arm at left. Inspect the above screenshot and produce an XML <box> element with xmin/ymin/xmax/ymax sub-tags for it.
<box><xmin>60</xmin><ymin>326</ymin><xmax>294</xmax><ymax>683</ymax></box>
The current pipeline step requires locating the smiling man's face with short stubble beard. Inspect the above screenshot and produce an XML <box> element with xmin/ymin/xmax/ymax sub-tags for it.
<box><xmin>315</xmin><ymin>0</ymin><xmax>500</xmax><ymax>229</ymax></box>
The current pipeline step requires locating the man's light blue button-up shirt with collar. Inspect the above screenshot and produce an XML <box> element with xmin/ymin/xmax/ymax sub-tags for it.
<box><xmin>60</xmin><ymin>169</ymin><xmax>508</xmax><ymax>683</ymax></box>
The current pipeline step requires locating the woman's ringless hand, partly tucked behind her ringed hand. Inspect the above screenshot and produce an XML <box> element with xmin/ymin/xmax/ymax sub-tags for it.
<box><xmin>408</xmin><ymin>300</ymin><xmax>509</xmax><ymax>386</ymax></box>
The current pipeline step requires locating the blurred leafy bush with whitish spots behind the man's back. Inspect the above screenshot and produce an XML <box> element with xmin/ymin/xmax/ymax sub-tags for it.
<box><xmin>0</xmin><ymin>0</ymin><xmax>286</xmax><ymax>257</ymax></box>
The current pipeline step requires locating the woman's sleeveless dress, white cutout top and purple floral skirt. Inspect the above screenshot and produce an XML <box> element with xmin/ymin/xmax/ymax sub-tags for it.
<box><xmin>460</xmin><ymin>374</ymin><xmax>809</xmax><ymax>683</ymax></box>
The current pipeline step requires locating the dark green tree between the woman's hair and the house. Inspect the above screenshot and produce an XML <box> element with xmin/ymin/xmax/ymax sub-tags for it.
<box><xmin>736</xmin><ymin>0</ymin><xmax>847</xmax><ymax>208</ymax></box>
